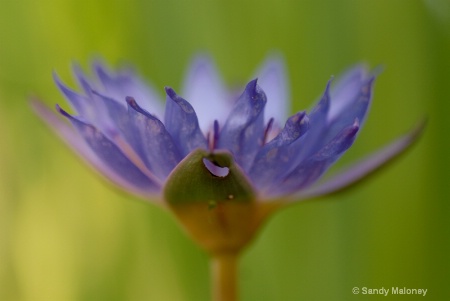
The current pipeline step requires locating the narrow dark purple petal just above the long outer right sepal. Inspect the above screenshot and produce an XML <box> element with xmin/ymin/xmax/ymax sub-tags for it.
<box><xmin>267</xmin><ymin>120</ymin><xmax>359</xmax><ymax>195</ymax></box>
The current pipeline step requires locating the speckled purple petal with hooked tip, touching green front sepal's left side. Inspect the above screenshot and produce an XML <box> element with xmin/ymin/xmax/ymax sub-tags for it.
<box><xmin>127</xmin><ymin>97</ymin><xmax>182</xmax><ymax>179</ymax></box>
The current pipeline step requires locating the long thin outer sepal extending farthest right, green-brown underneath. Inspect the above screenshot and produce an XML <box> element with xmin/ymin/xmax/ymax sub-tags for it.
<box><xmin>291</xmin><ymin>122</ymin><xmax>425</xmax><ymax>201</ymax></box>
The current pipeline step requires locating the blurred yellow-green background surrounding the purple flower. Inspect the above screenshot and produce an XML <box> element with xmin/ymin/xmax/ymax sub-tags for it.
<box><xmin>0</xmin><ymin>0</ymin><xmax>450</xmax><ymax>301</ymax></box>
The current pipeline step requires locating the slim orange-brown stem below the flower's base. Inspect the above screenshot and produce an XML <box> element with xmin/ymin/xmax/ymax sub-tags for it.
<box><xmin>211</xmin><ymin>253</ymin><xmax>239</xmax><ymax>301</ymax></box>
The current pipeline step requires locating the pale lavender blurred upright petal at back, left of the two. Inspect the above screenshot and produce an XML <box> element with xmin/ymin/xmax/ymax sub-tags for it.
<box><xmin>182</xmin><ymin>56</ymin><xmax>232</xmax><ymax>133</ymax></box>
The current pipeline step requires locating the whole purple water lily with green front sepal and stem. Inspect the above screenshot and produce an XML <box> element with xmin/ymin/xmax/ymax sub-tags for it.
<box><xmin>33</xmin><ymin>57</ymin><xmax>423</xmax><ymax>300</ymax></box>
